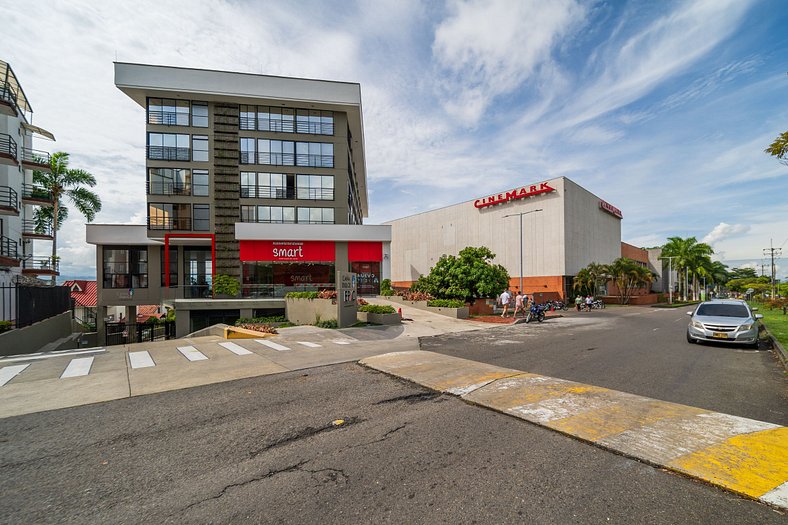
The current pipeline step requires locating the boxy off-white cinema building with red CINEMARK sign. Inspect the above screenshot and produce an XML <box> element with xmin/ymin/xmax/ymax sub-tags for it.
<box><xmin>387</xmin><ymin>177</ymin><xmax>622</xmax><ymax>300</ymax></box>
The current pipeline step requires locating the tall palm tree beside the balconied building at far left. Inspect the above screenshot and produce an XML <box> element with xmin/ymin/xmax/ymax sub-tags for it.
<box><xmin>33</xmin><ymin>151</ymin><xmax>101</xmax><ymax>285</ymax></box>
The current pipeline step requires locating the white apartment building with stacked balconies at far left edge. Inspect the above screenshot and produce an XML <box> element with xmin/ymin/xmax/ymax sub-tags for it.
<box><xmin>0</xmin><ymin>61</ymin><xmax>58</xmax><ymax>296</ymax></box>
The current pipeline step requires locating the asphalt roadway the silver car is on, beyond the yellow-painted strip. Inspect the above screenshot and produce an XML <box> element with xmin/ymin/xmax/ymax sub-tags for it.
<box><xmin>421</xmin><ymin>307</ymin><xmax>788</xmax><ymax>426</ymax></box>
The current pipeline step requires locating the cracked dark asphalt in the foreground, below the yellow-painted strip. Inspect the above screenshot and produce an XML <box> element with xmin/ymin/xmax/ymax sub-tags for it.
<box><xmin>0</xmin><ymin>360</ymin><xmax>785</xmax><ymax>525</ymax></box>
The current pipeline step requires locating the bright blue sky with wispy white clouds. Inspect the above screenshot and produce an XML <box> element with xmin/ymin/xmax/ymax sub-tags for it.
<box><xmin>0</xmin><ymin>0</ymin><xmax>788</xmax><ymax>277</ymax></box>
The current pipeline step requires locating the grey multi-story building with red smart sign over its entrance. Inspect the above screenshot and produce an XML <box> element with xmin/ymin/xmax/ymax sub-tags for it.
<box><xmin>87</xmin><ymin>63</ymin><xmax>391</xmax><ymax>335</ymax></box>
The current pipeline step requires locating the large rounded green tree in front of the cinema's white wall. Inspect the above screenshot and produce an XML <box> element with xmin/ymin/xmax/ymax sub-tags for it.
<box><xmin>413</xmin><ymin>246</ymin><xmax>509</xmax><ymax>300</ymax></box>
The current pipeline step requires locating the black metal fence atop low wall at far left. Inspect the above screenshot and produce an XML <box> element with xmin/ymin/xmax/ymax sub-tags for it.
<box><xmin>0</xmin><ymin>284</ymin><xmax>71</xmax><ymax>328</ymax></box>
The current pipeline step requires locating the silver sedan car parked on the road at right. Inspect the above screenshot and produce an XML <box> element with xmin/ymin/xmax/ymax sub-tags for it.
<box><xmin>687</xmin><ymin>300</ymin><xmax>763</xmax><ymax>348</ymax></box>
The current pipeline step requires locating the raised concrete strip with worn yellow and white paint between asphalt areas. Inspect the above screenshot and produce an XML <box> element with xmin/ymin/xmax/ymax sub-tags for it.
<box><xmin>361</xmin><ymin>351</ymin><xmax>788</xmax><ymax>510</ymax></box>
